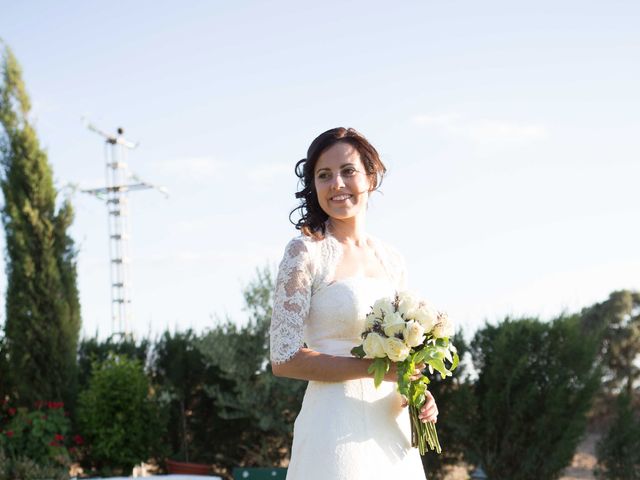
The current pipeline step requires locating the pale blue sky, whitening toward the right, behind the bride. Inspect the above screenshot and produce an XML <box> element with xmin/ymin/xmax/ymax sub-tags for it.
<box><xmin>0</xmin><ymin>0</ymin><xmax>640</xmax><ymax>336</ymax></box>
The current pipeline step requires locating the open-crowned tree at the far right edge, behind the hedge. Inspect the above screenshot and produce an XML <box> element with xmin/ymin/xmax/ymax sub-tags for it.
<box><xmin>581</xmin><ymin>290</ymin><xmax>640</xmax><ymax>396</ymax></box>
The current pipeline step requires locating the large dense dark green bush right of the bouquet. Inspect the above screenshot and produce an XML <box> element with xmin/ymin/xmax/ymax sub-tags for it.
<box><xmin>455</xmin><ymin>316</ymin><xmax>600</xmax><ymax>480</ymax></box>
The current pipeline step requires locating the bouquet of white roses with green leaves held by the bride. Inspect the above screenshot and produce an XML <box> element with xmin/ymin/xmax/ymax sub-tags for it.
<box><xmin>351</xmin><ymin>292</ymin><xmax>459</xmax><ymax>455</ymax></box>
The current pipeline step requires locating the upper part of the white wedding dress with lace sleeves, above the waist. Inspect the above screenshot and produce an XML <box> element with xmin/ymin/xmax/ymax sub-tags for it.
<box><xmin>270</xmin><ymin>232</ymin><xmax>405</xmax><ymax>363</ymax></box>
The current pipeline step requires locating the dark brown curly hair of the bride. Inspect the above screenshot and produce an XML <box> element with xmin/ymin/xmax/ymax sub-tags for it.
<box><xmin>289</xmin><ymin>127</ymin><xmax>387</xmax><ymax>238</ymax></box>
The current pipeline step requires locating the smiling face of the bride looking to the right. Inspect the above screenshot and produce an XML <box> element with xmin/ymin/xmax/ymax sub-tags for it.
<box><xmin>313</xmin><ymin>142</ymin><xmax>371</xmax><ymax>220</ymax></box>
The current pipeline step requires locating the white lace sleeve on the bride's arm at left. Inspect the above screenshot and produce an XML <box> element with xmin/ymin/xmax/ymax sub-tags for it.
<box><xmin>270</xmin><ymin>238</ymin><xmax>313</xmax><ymax>364</ymax></box>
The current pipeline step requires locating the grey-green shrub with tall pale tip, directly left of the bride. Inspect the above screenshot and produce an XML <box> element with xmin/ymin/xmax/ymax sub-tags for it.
<box><xmin>199</xmin><ymin>268</ymin><xmax>306</xmax><ymax>467</ymax></box>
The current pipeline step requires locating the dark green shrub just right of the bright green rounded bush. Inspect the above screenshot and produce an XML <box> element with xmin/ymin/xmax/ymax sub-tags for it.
<box><xmin>151</xmin><ymin>330</ymin><xmax>222</xmax><ymax>463</ymax></box>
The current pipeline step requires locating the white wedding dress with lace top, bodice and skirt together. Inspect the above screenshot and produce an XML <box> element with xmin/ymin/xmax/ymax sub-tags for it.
<box><xmin>271</xmin><ymin>233</ymin><xmax>425</xmax><ymax>480</ymax></box>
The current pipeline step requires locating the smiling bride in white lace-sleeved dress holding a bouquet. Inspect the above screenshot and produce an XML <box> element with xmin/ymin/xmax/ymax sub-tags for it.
<box><xmin>270</xmin><ymin>128</ymin><xmax>438</xmax><ymax>480</ymax></box>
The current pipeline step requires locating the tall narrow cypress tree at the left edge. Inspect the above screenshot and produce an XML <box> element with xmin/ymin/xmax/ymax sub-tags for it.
<box><xmin>0</xmin><ymin>47</ymin><xmax>80</xmax><ymax>403</ymax></box>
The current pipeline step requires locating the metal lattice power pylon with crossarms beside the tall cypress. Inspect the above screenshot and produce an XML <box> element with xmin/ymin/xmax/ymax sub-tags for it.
<box><xmin>82</xmin><ymin>122</ymin><xmax>166</xmax><ymax>335</ymax></box>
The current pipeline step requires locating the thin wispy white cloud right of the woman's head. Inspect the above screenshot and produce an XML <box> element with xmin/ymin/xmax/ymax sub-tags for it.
<box><xmin>412</xmin><ymin>113</ymin><xmax>548</xmax><ymax>144</ymax></box>
